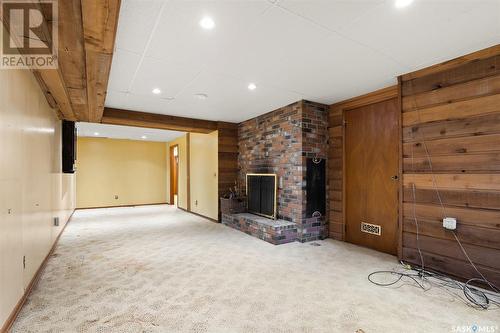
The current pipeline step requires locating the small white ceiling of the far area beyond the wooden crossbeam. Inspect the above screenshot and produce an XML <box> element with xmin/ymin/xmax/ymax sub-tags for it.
<box><xmin>76</xmin><ymin>123</ymin><xmax>186</xmax><ymax>142</ymax></box>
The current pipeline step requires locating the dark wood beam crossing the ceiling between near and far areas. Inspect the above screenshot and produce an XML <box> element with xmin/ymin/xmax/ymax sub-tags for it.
<box><xmin>102</xmin><ymin>108</ymin><xmax>218</xmax><ymax>133</ymax></box>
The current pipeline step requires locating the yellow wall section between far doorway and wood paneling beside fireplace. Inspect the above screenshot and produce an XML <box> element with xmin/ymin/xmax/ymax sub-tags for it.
<box><xmin>189</xmin><ymin>131</ymin><xmax>219</xmax><ymax>220</ymax></box>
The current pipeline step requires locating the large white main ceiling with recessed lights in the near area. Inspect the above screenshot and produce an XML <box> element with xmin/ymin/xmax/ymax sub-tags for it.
<box><xmin>106</xmin><ymin>0</ymin><xmax>500</xmax><ymax>122</ymax></box>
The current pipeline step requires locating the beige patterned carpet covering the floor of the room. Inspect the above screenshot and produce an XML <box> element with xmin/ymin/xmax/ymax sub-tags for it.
<box><xmin>13</xmin><ymin>206</ymin><xmax>500</xmax><ymax>333</ymax></box>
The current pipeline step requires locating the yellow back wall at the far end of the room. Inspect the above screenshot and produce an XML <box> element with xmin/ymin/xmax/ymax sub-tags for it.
<box><xmin>76</xmin><ymin>137</ymin><xmax>167</xmax><ymax>208</ymax></box>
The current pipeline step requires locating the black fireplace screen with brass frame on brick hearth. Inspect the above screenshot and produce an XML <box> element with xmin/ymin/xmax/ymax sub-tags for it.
<box><xmin>247</xmin><ymin>173</ymin><xmax>276</xmax><ymax>219</ymax></box>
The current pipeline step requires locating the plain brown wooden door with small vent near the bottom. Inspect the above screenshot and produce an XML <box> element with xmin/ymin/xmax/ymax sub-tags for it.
<box><xmin>345</xmin><ymin>99</ymin><xmax>400</xmax><ymax>254</ymax></box>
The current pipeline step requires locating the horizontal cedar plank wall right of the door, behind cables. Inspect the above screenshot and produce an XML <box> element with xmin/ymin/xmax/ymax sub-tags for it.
<box><xmin>400</xmin><ymin>46</ymin><xmax>500</xmax><ymax>286</ymax></box>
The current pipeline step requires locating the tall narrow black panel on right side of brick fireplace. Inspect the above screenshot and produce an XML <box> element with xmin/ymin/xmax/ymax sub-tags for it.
<box><xmin>306</xmin><ymin>158</ymin><xmax>326</xmax><ymax>218</ymax></box>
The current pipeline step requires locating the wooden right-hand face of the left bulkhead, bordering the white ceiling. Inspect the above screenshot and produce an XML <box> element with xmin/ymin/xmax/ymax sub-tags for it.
<box><xmin>81</xmin><ymin>0</ymin><xmax>121</xmax><ymax>123</ymax></box>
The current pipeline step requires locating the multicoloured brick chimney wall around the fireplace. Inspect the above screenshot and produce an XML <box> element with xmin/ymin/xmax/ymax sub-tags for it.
<box><xmin>238</xmin><ymin>101</ymin><xmax>328</xmax><ymax>241</ymax></box>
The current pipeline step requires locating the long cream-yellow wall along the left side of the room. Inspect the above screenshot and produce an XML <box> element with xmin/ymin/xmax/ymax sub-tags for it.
<box><xmin>0</xmin><ymin>70</ymin><xmax>75</xmax><ymax>326</ymax></box>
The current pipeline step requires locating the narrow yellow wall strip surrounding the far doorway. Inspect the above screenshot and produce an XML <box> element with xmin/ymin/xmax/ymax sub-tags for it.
<box><xmin>166</xmin><ymin>135</ymin><xmax>188</xmax><ymax>209</ymax></box>
